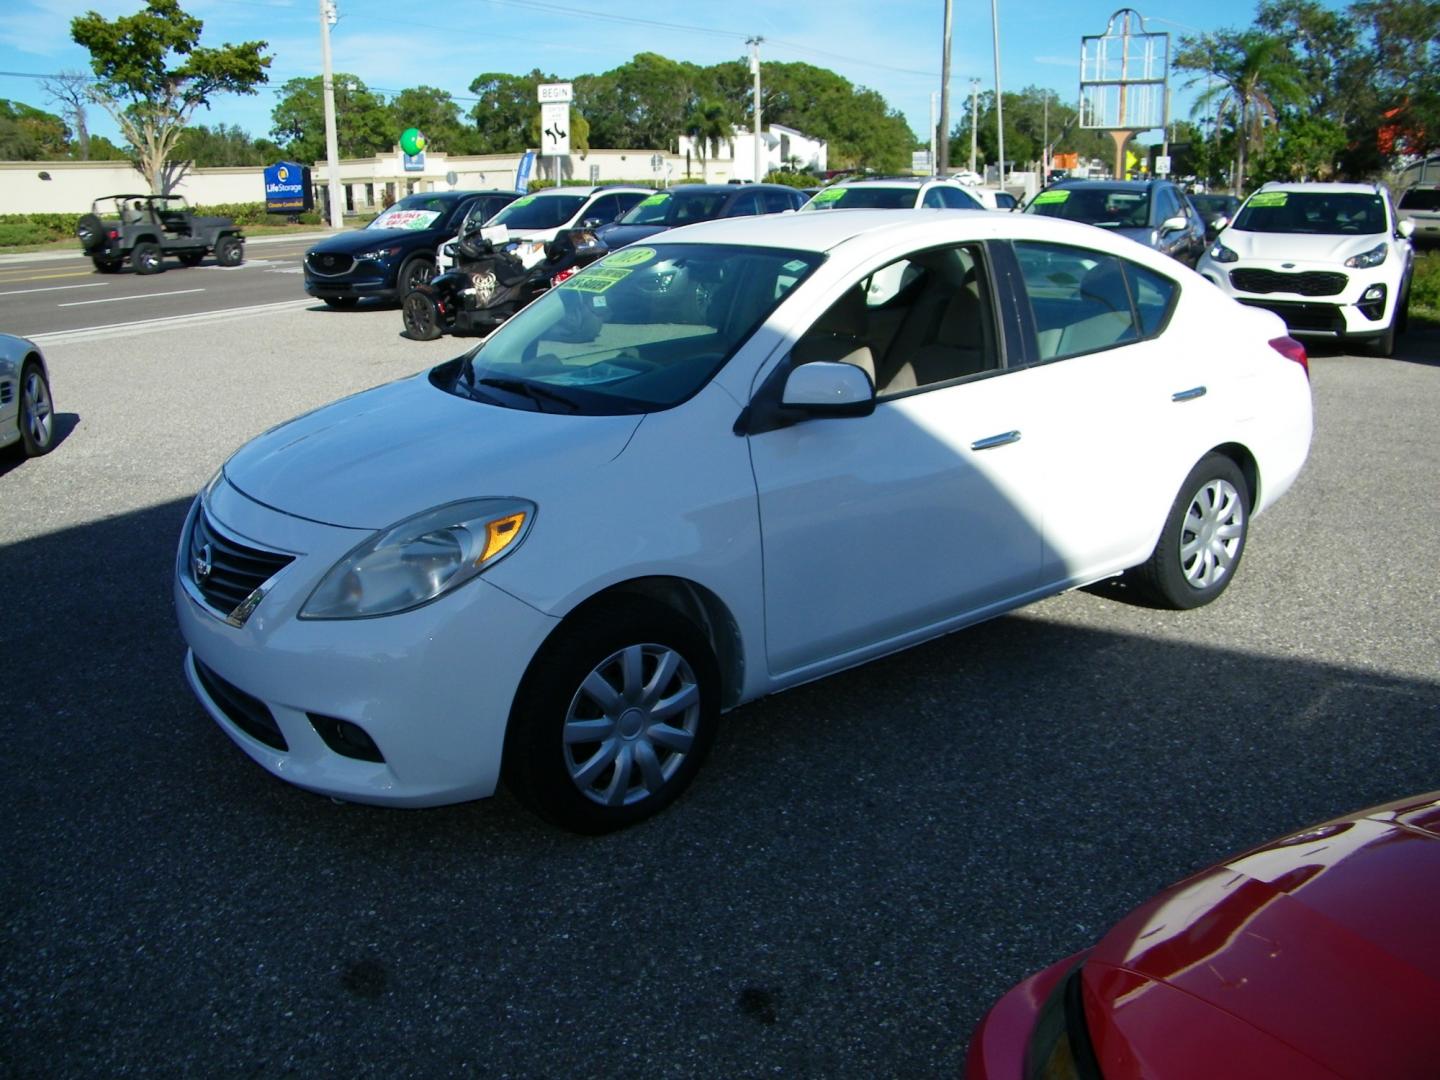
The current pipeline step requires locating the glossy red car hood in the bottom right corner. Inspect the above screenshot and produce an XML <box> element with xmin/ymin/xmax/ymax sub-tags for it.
<box><xmin>1086</xmin><ymin>792</ymin><xmax>1440</xmax><ymax>1076</ymax></box>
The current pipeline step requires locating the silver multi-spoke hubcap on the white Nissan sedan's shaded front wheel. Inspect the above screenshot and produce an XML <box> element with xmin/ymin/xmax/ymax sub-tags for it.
<box><xmin>564</xmin><ymin>645</ymin><xmax>700</xmax><ymax>806</ymax></box>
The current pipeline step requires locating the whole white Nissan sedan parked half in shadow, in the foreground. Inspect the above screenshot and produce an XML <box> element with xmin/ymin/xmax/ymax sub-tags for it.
<box><xmin>174</xmin><ymin>210</ymin><xmax>1310</xmax><ymax>832</ymax></box>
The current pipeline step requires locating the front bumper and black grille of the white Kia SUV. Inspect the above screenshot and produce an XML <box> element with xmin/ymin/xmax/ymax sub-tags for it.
<box><xmin>1197</xmin><ymin>252</ymin><xmax>1400</xmax><ymax>337</ymax></box>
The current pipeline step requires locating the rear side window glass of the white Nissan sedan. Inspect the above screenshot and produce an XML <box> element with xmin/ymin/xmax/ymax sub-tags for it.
<box><xmin>1014</xmin><ymin>240</ymin><xmax>1175</xmax><ymax>361</ymax></box>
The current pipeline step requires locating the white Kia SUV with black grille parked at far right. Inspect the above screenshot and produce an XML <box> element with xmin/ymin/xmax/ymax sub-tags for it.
<box><xmin>1195</xmin><ymin>184</ymin><xmax>1414</xmax><ymax>356</ymax></box>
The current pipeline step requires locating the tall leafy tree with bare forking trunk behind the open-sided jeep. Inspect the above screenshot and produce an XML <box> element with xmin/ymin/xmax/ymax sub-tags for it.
<box><xmin>71</xmin><ymin>0</ymin><xmax>271</xmax><ymax>194</ymax></box>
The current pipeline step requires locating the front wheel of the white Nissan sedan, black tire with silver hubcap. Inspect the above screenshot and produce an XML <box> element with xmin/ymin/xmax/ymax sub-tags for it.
<box><xmin>504</xmin><ymin>598</ymin><xmax>720</xmax><ymax>835</ymax></box>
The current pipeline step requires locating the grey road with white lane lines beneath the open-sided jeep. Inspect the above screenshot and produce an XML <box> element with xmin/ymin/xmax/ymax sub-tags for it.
<box><xmin>0</xmin><ymin>236</ymin><xmax>324</xmax><ymax>337</ymax></box>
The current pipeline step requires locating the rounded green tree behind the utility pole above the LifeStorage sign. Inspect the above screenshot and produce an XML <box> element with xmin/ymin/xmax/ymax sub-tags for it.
<box><xmin>271</xmin><ymin>72</ymin><xmax>400</xmax><ymax>164</ymax></box>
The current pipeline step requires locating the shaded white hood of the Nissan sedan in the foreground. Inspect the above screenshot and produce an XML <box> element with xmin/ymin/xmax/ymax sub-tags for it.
<box><xmin>225</xmin><ymin>374</ymin><xmax>641</xmax><ymax>528</ymax></box>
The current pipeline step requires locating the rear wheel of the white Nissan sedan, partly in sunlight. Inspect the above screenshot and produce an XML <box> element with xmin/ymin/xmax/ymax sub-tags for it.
<box><xmin>1138</xmin><ymin>454</ymin><xmax>1251</xmax><ymax>611</ymax></box>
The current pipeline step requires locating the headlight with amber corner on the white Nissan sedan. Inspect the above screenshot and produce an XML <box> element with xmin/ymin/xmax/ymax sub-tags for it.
<box><xmin>300</xmin><ymin>498</ymin><xmax>536</xmax><ymax>619</ymax></box>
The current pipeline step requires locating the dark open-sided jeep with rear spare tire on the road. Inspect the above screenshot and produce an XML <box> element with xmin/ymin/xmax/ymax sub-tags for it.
<box><xmin>75</xmin><ymin>194</ymin><xmax>245</xmax><ymax>274</ymax></box>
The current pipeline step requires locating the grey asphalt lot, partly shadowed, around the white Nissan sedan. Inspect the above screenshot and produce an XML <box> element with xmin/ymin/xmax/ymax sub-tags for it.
<box><xmin>0</xmin><ymin>302</ymin><xmax>1440</xmax><ymax>1077</ymax></box>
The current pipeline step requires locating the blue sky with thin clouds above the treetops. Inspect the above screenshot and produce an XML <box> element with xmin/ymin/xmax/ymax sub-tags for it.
<box><xmin>0</xmin><ymin>0</ymin><xmax>1301</xmax><ymax>154</ymax></box>
